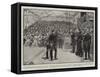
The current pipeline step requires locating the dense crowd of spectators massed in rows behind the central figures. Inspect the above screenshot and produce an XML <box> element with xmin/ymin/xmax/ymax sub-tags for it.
<box><xmin>24</xmin><ymin>21</ymin><xmax>73</xmax><ymax>48</ymax></box>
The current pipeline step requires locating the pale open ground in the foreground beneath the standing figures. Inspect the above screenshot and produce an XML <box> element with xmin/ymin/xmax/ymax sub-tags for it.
<box><xmin>24</xmin><ymin>47</ymin><xmax>90</xmax><ymax>64</ymax></box>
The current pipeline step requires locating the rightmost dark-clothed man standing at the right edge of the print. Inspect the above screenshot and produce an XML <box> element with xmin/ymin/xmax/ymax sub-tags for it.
<box><xmin>83</xmin><ymin>31</ymin><xmax>91</xmax><ymax>60</ymax></box>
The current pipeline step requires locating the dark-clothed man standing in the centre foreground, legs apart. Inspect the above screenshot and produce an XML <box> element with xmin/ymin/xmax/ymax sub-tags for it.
<box><xmin>48</xmin><ymin>30</ymin><xmax>57</xmax><ymax>60</ymax></box>
